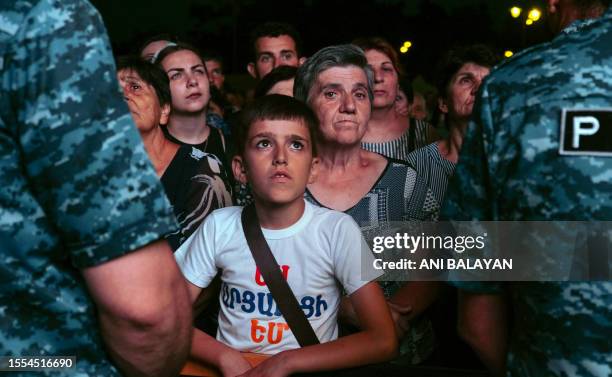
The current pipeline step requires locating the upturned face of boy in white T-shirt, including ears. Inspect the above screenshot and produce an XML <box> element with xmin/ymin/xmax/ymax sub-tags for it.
<box><xmin>232</xmin><ymin>120</ymin><xmax>318</xmax><ymax>206</ymax></box>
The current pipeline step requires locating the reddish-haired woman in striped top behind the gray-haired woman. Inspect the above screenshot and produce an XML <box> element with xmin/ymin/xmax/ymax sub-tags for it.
<box><xmin>353</xmin><ymin>38</ymin><xmax>437</xmax><ymax>160</ymax></box>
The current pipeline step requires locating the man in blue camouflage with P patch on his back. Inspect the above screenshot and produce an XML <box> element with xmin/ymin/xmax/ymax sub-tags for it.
<box><xmin>443</xmin><ymin>0</ymin><xmax>612</xmax><ymax>377</ymax></box>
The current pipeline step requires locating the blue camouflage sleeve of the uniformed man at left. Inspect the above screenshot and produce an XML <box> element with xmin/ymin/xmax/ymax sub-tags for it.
<box><xmin>2</xmin><ymin>0</ymin><xmax>176</xmax><ymax>268</ymax></box>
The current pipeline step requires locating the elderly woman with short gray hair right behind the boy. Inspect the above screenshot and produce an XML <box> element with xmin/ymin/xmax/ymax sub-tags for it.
<box><xmin>293</xmin><ymin>45</ymin><xmax>437</xmax><ymax>363</ymax></box>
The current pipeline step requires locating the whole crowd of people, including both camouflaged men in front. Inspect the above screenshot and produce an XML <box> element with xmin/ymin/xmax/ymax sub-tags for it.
<box><xmin>0</xmin><ymin>0</ymin><xmax>612</xmax><ymax>377</ymax></box>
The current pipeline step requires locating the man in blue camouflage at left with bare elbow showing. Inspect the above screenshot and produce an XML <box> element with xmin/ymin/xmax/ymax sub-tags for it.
<box><xmin>0</xmin><ymin>0</ymin><xmax>191</xmax><ymax>376</ymax></box>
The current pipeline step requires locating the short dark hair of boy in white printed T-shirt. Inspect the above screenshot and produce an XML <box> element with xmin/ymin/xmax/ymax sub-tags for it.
<box><xmin>232</xmin><ymin>94</ymin><xmax>319</xmax><ymax>156</ymax></box>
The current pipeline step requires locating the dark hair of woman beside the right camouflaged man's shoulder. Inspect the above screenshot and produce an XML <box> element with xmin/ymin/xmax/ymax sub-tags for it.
<box><xmin>436</xmin><ymin>44</ymin><xmax>500</xmax><ymax>97</ymax></box>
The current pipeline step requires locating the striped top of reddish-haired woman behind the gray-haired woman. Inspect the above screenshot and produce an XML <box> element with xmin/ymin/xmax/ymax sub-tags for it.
<box><xmin>361</xmin><ymin>118</ymin><xmax>430</xmax><ymax>161</ymax></box>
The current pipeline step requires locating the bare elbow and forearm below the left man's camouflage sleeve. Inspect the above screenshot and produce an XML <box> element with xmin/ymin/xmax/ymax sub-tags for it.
<box><xmin>83</xmin><ymin>241</ymin><xmax>191</xmax><ymax>376</ymax></box>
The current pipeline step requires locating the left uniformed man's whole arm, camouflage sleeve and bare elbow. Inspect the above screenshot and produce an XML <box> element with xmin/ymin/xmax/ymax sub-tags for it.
<box><xmin>10</xmin><ymin>0</ymin><xmax>191</xmax><ymax>376</ymax></box>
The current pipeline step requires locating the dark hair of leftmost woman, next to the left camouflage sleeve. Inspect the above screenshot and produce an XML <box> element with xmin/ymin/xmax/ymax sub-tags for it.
<box><xmin>117</xmin><ymin>55</ymin><xmax>172</xmax><ymax>106</ymax></box>
